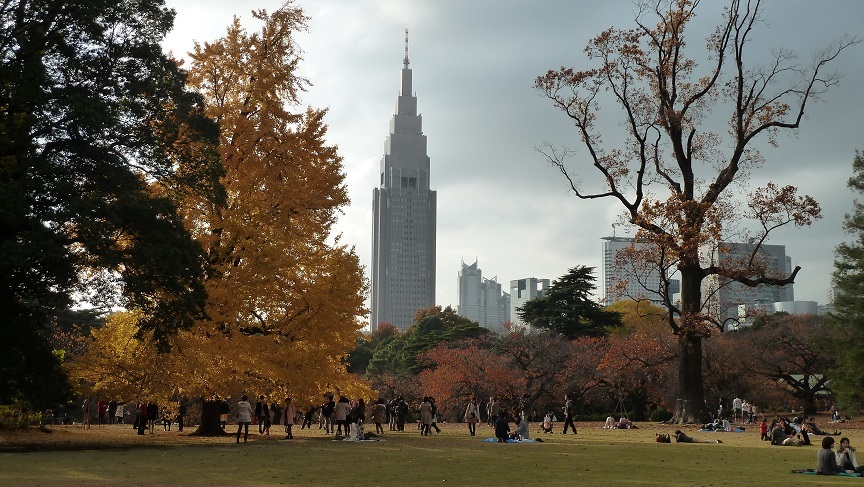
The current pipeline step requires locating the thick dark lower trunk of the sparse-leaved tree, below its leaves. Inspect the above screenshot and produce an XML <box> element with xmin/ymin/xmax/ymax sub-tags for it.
<box><xmin>672</xmin><ymin>334</ymin><xmax>710</xmax><ymax>424</ymax></box>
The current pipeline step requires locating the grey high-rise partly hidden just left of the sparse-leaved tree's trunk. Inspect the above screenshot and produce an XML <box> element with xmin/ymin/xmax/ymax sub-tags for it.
<box><xmin>600</xmin><ymin>237</ymin><xmax>681</xmax><ymax>306</ymax></box>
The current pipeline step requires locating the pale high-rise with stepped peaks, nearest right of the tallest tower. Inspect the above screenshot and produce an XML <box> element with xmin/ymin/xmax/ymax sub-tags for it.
<box><xmin>457</xmin><ymin>260</ymin><xmax>510</xmax><ymax>330</ymax></box>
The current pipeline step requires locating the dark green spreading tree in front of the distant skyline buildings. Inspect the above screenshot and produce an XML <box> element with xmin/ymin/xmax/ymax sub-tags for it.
<box><xmin>516</xmin><ymin>266</ymin><xmax>621</xmax><ymax>339</ymax></box>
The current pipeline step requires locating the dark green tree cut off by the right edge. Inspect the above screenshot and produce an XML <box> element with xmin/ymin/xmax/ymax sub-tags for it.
<box><xmin>829</xmin><ymin>151</ymin><xmax>864</xmax><ymax>410</ymax></box>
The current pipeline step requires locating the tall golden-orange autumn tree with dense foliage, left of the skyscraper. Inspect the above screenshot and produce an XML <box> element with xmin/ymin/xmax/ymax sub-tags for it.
<box><xmin>172</xmin><ymin>2</ymin><xmax>371</xmax><ymax>426</ymax></box>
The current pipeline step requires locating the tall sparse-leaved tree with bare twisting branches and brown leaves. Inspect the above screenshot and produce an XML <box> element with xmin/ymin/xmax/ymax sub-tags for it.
<box><xmin>535</xmin><ymin>0</ymin><xmax>858</xmax><ymax>423</ymax></box>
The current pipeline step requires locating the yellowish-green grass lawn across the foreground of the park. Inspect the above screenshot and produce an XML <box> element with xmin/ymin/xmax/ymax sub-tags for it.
<box><xmin>0</xmin><ymin>421</ymin><xmax>864</xmax><ymax>487</ymax></box>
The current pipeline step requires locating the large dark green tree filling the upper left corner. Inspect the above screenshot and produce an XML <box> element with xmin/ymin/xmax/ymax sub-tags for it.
<box><xmin>0</xmin><ymin>0</ymin><xmax>221</xmax><ymax>407</ymax></box>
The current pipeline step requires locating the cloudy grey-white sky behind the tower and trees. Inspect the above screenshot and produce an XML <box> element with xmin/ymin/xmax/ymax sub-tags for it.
<box><xmin>165</xmin><ymin>0</ymin><xmax>864</xmax><ymax>318</ymax></box>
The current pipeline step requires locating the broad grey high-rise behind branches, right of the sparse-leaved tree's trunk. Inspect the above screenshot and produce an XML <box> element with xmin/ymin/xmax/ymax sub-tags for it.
<box><xmin>702</xmin><ymin>242</ymin><xmax>795</xmax><ymax>321</ymax></box>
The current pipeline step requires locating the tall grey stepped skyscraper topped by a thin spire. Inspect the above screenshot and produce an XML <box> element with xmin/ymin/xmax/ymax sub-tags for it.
<box><xmin>370</xmin><ymin>29</ymin><xmax>436</xmax><ymax>331</ymax></box>
